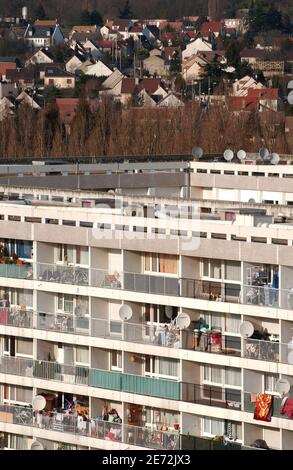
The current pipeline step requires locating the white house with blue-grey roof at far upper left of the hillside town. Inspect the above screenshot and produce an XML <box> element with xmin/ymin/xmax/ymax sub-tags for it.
<box><xmin>24</xmin><ymin>21</ymin><xmax>64</xmax><ymax>48</ymax></box>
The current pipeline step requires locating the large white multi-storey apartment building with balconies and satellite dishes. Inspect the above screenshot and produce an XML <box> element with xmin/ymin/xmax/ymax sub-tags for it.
<box><xmin>0</xmin><ymin>156</ymin><xmax>293</xmax><ymax>450</ymax></box>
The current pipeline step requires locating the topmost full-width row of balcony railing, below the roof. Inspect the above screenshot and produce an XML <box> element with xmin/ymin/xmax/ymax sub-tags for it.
<box><xmin>0</xmin><ymin>263</ymin><xmax>293</xmax><ymax>310</ymax></box>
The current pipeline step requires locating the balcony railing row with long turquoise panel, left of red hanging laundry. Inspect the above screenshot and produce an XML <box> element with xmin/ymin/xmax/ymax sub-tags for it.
<box><xmin>0</xmin><ymin>356</ymin><xmax>241</xmax><ymax>410</ymax></box>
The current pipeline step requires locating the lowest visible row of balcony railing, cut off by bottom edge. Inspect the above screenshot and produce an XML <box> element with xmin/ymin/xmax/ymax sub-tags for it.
<box><xmin>0</xmin><ymin>405</ymin><xmax>242</xmax><ymax>450</ymax></box>
